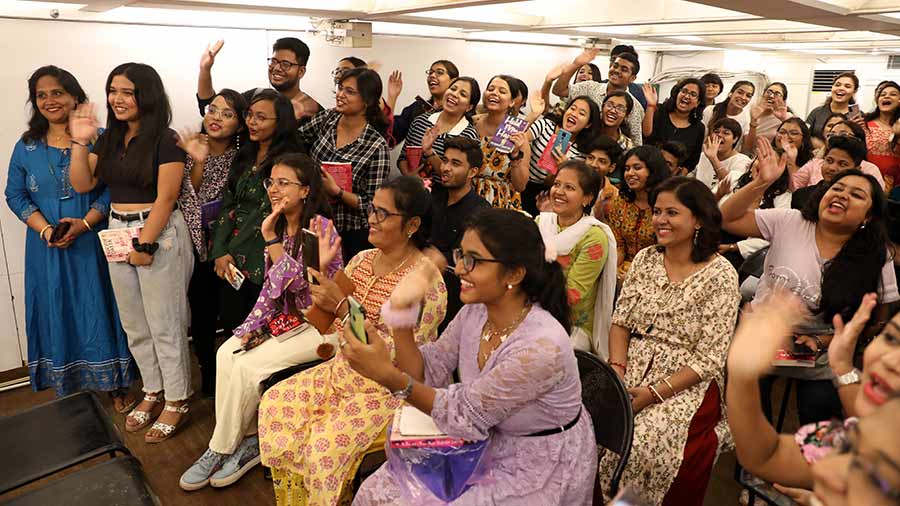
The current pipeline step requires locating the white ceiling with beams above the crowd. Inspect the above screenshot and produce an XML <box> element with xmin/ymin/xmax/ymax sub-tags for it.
<box><xmin>12</xmin><ymin>0</ymin><xmax>900</xmax><ymax>54</ymax></box>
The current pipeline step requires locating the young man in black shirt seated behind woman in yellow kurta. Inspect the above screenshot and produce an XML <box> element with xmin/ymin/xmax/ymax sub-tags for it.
<box><xmin>426</xmin><ymin>136</ymin><xmax>490</xmax><ymax>331</ymax></box>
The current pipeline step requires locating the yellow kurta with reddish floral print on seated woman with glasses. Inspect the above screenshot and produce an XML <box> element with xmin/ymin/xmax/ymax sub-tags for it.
<box><xmin>259</xmin><ymin>249</ymin><xmax>447</xmax><ymax>506</ymax></box>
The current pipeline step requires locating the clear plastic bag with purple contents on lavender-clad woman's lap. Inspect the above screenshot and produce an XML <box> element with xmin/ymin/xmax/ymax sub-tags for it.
<box><xmin>385</xmin><ymin>439</ymin><xmax>490</xmax><ymax>506</ymax></box>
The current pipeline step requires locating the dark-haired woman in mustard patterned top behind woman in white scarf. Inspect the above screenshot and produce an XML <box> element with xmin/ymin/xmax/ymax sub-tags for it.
<box><xmin>607</xmin><ymin>146</ymin><xmax>669</xmax><ymax>282</ymax></box>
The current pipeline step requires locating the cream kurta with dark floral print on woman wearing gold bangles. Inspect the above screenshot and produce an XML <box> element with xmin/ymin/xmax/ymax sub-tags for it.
<box><xmin>600</xmin><ymin>247</ymin><xmax>741</xmax><ymax>504</ymax></box>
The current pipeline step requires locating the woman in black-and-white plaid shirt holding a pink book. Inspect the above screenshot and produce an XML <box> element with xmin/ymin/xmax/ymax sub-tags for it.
<box><xmin>299</xmin><ymin>68</ymin><xmax>390</xmax><ymax>258</ymax></box>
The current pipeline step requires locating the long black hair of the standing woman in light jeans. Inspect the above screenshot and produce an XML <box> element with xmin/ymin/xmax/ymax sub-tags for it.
<box><xmin>97</xmin><ymin>62</ymin><xmax>172</xmax><ymax>186</ymax></box>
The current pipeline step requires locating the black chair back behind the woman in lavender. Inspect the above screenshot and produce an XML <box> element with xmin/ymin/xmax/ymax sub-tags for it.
<box><xmin>575</xmin><ymin>350</ymin><xmax>634</xmax><ymax>497</ymax></box>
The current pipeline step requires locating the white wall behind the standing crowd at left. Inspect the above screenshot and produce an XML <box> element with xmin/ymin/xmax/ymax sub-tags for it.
<box><xmin>0</xmin><ymin>19</ymin><xmax>654</xmax><ymax>371</ymax></box>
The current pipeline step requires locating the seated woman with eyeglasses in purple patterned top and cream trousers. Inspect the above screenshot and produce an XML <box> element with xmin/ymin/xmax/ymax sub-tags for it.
<box><xmin>179</xmin><ymin>153</ymin><xmax>343</xmax><ymax>491</ymax></box>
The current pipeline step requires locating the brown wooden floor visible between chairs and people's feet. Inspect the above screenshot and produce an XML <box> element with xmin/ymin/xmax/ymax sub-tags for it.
<box><xmin>0</xmin><ymin>356</ymin><xmax>797</xmax><ymax>506</ymax></box>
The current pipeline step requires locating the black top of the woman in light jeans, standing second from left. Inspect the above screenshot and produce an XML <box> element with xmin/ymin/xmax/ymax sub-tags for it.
<box><xmin>92</xmin><ymin>128</ymin><xmax>187</xmax><ymax>204</ymax></box>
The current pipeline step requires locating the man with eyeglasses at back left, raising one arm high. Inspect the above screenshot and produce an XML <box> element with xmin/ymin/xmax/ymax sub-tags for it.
<box><xmin>197</xmin><ymin>37</ymin><xmax>322</xmax><ymax>123</ymax></box>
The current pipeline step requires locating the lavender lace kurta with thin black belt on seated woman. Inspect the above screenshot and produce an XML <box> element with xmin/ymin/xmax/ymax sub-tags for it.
<box><xmin>353</xmin><ymin>304</ymin><xmax>597</xmax><ymax>506</ymax></box>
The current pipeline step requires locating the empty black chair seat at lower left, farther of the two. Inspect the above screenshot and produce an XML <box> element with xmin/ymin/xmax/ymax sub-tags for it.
<box><xmin>0</xmin><ymin>392</ymin><xmax>131</xmax><ymax>494</ymax></box>
